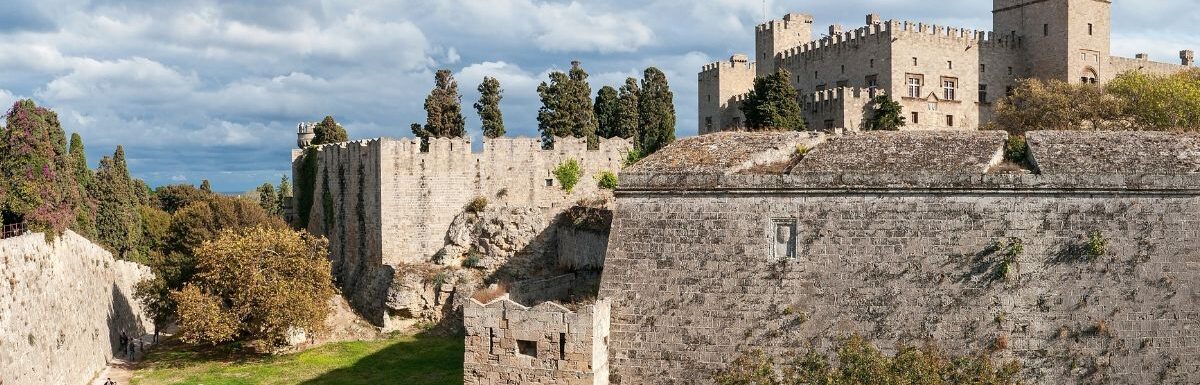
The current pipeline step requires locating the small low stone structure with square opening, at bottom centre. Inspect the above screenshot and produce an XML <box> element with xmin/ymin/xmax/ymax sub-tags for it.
<box><xmin>463</xmin><ymin>275</ymin><xmax>611</xmax><ymax>385</ymax></box>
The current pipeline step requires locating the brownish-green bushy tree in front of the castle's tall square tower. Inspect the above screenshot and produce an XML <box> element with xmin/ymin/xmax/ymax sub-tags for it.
<box><xmin>988</xmin><ymin>79</ymin><xmax>1124</xmax><ymax>136</ymax></box>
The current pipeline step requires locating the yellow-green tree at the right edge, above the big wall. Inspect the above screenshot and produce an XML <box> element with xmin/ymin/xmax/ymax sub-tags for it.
<box><xmin>1105</xmin><ymin>68</ymin><xmax>1200</xmax><ymax>131</ymax></box>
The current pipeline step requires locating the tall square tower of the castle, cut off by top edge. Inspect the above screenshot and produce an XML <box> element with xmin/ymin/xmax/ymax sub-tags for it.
<box><xmin>992</xmin><ymin>0</ymin><xmax>1116</xmax><ymax>83</ymax></box>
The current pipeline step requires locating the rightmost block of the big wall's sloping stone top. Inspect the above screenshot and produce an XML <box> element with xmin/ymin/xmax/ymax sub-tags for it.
<box><xmin>1027</xmin><ymin>131</ymin><xmax>1200</xmax><ymax>175</ymax></box>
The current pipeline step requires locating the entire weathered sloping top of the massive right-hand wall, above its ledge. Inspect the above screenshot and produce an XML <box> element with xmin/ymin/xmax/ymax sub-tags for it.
<box><xmin>618</xmin><ymin>131</ymin><xmax>1200</xmax><ymax>190</ymax></box>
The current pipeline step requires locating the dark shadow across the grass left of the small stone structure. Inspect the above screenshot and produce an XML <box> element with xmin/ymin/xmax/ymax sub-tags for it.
<box><xmin>301</xmin><ymin>333</ymin><xmax>463</xmax><ymax>385</ymax></box>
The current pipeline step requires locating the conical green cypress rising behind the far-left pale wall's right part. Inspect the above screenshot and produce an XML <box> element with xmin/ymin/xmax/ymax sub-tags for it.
<box><xmin>96</xmin><ymin>146</ymin><xmax>142</xmax><ymax>260</ymax></box>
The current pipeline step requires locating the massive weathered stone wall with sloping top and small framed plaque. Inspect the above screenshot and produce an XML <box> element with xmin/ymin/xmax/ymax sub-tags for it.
<box><xmin>597</xmin><ymin>131</ymin><xmax>1200</xmax><ymax>384</ymax></box>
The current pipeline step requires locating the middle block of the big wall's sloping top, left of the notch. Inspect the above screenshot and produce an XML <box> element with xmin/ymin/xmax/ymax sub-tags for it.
<box><xmin>792</xmin><ymin>131</ymin><xmax>1008</xmax><ymax>174</ymax></box>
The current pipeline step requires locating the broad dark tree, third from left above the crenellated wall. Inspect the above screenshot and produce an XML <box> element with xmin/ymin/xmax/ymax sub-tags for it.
<box><xmin>538</xmin><ymin>61</ymin><xmax>596</xmax><ymax>149</ymax></box>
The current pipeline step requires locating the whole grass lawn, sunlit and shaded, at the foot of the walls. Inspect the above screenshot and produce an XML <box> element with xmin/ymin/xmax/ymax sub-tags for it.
<box><xmin>132</xmin><ymin>335</ymin><xmax>463</xmax><ymax>385</ymax></box>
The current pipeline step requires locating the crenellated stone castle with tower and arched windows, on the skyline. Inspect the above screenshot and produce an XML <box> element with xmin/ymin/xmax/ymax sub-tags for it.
<box><xmin>698</xmin><ymin>0</ymin><xmax>1195</xmax><ymax>134</ymax></box>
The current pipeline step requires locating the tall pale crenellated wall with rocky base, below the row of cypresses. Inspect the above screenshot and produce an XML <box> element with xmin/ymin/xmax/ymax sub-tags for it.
<box><xmin>293</xmin><ymin>134</ymin><xmax>631</xmax><ymax>326</ymax></box>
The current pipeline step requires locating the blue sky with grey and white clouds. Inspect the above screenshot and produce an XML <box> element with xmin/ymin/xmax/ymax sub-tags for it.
<box><xmin>0</xmin><ymin>0</ymin><xmax>1200</xmax><ymax>192</ymax></box>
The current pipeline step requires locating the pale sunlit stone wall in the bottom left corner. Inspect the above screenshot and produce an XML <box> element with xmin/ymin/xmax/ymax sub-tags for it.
<box><xmin>0</xmin><ymin>231</ymin><xmax>154</xmax><ymax>385</ymax></box>
